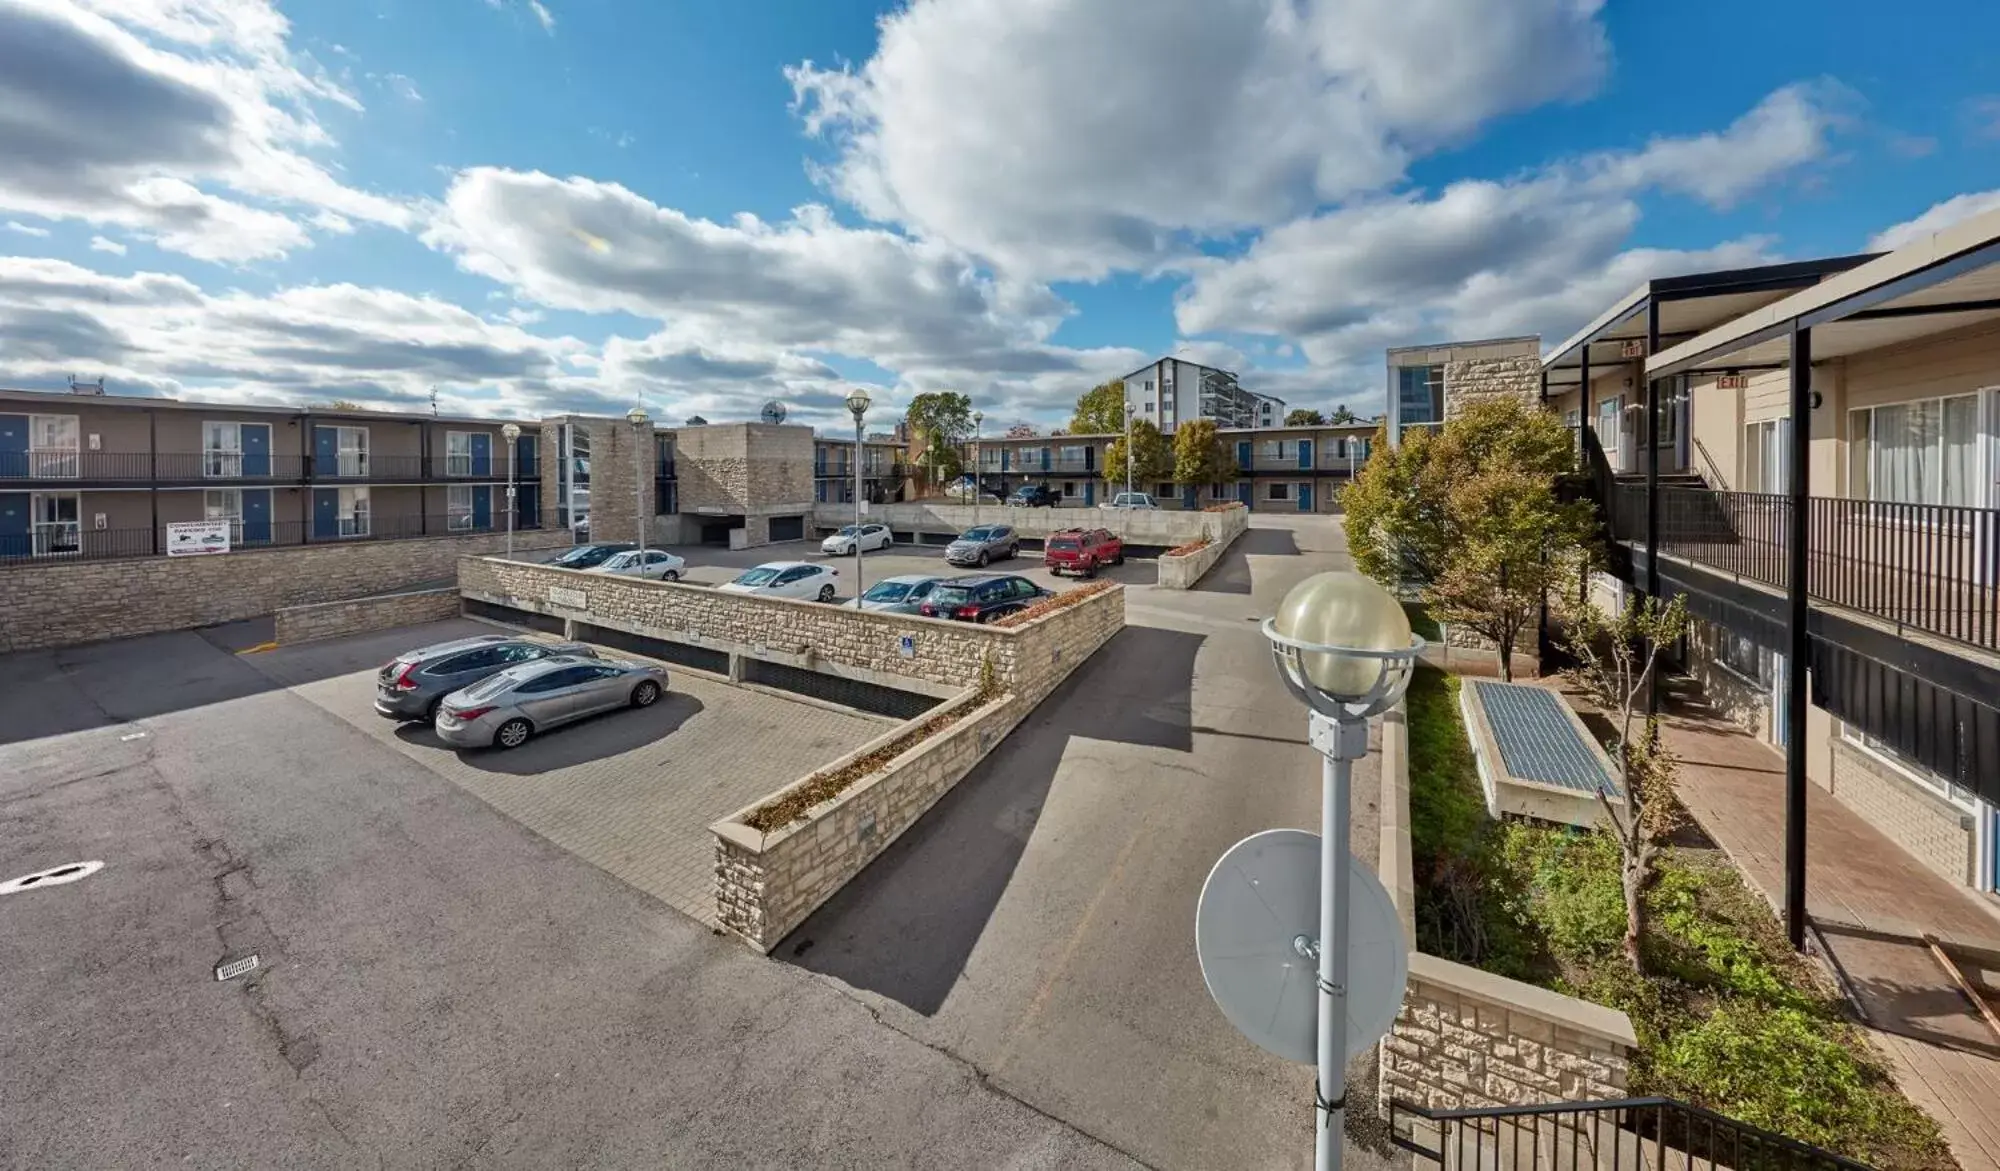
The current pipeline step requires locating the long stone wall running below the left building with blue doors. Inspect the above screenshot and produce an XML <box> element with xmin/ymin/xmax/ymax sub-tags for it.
<box><xmin>0</xmin><ymin>530</ymin><xmax>570</xmax><ymax>651</ymax></box>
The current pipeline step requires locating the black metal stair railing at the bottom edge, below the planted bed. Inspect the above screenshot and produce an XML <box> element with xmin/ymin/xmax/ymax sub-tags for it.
<box><xmin>1388</xmin><ymin>1097</ymin><xmax>1870</xmax><ymax>1171</ymax></box>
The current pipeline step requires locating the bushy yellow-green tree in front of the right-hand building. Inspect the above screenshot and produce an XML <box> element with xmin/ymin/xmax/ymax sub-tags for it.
<box><xmin>1340</xmin><ymin>400</ymin><xmax>1594</xmax><ymax>679</ymax></box>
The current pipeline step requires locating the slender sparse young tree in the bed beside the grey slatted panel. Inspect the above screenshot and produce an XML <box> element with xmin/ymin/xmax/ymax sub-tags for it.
<box><xmin>1564</xmin><ymin>578</ymin><xmax>1688</xmax><ymax>975</ymax></box>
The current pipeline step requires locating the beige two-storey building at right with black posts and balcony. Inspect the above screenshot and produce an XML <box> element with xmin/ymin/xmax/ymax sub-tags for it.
<box><xmin>1544</xmin><ymin>214</ymin><xmax>2000</xmax><ymax>919</ymax></box>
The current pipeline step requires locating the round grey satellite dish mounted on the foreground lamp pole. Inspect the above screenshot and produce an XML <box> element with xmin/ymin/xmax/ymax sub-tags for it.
<box><xmin>1194</xmin><ymin>829</ymin><xmax>1410</xmax><ymax>1065</ymax></box>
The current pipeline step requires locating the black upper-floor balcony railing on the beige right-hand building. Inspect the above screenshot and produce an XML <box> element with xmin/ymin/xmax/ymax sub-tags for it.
<box><xmin>1612</xmin><ymin>484</ymin><xmax>2000</xmax><ymax>649</ymax></box>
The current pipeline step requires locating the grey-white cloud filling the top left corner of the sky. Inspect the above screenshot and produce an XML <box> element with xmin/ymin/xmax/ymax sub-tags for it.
<box><xmin>0</xmin><ymin>0</ymin><xmax>412</xmax><ymax>262</ymax></box>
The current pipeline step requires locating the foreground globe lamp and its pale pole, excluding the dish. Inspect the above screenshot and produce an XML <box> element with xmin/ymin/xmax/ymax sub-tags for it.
<box><xmin>1262</xmin><ymin>574</ymin><xmax>1424</xmax><ymax>1171</ymax></box>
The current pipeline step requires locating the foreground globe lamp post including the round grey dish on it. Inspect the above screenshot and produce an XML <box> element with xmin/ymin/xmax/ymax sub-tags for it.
<box><xmin>1194</xmin><ymin>574</ymin><xmax>1424</xmax><ymax>1171</ymax></box>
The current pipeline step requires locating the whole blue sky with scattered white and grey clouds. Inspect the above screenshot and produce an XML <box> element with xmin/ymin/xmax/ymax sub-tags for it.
<box><xmin>0</xmin><ymin>0</ymin><xmax>2000</xmax><ymax>428</ymax></box>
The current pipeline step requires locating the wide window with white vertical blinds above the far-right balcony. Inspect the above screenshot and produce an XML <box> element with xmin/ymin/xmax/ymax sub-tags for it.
<box><xmin>1848</xmin><ymin>394</ymin><xmax>1986</xmax><ymax>506</ymax></box>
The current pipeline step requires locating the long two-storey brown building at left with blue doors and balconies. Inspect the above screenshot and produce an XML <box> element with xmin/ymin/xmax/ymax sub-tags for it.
<box><xmin>0</xmin><ymin>388</ymin><xmax>540</xmax><ymax>560</ymax></box>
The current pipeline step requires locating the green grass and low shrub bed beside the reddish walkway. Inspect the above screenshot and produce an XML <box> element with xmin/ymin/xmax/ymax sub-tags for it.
<box><xmin>1410</xmin><ymin>667</ymin><xmax>1956</xmax><ymax>1171</ymax></box>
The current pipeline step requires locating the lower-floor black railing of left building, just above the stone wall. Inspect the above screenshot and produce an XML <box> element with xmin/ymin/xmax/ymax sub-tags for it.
<box><xmin>0</xmin><ymin>510</ymin><xmax>540</xmax><ymax>568</ymax></box>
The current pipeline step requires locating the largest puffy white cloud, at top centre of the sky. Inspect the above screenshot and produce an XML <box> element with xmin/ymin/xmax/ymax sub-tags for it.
<box><xmin>786</xmin><ymin>0</ymin><xmax>1608</xmax><ymax>280</ymax></box>
